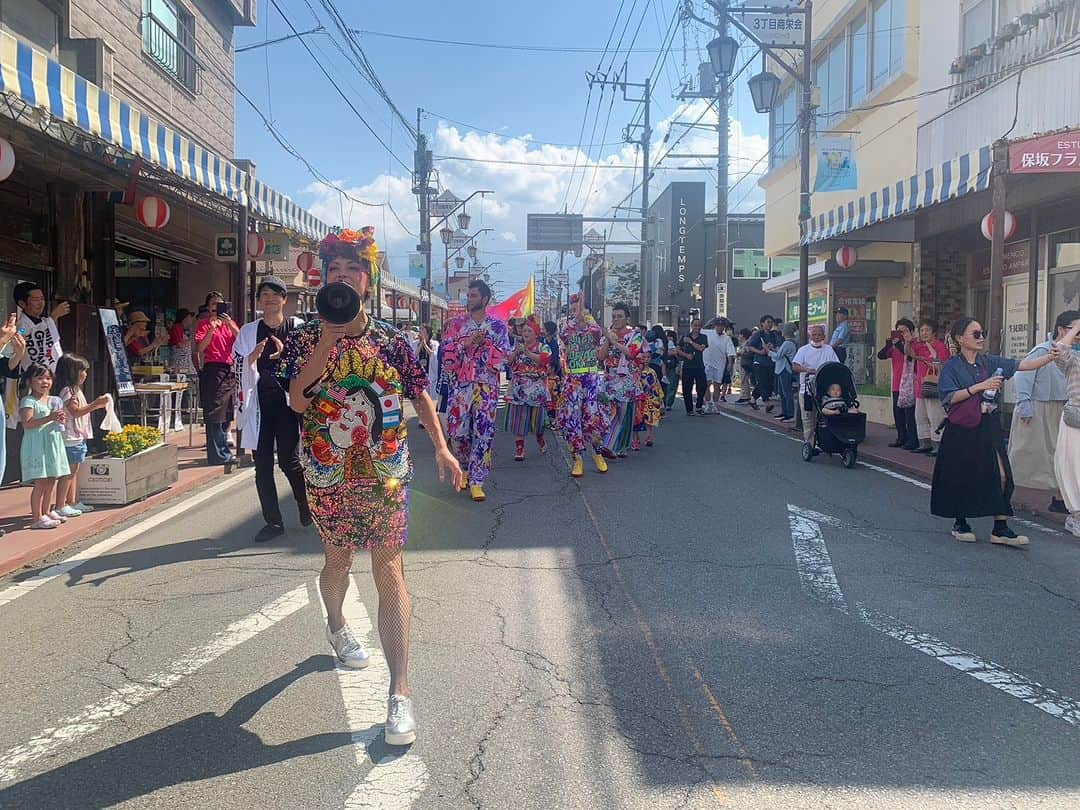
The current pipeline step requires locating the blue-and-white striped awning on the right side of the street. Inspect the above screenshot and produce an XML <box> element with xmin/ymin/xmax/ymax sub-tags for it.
<box><xmin>801</xmin><ymin>146</ymin><xmax>993</xmax><ymax>245</ymax></box>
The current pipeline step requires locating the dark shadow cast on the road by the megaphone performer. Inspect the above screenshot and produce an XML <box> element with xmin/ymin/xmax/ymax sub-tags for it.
<box><xmin>0</xmin><ymin>656</ymin><xmax>352</xmax><ymax>808</ymax></box>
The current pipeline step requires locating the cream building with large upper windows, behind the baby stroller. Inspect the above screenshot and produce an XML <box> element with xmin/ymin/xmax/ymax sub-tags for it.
<box><xmin>759</xmin><ymin>0</ymin><xmax>936</xmax><ymax>383</ymax></box>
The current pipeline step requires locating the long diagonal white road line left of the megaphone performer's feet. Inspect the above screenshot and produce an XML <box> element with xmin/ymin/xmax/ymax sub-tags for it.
<box><xmin>0</xmin><ymin>585</ymin><xmax>308</xmax><ymax>784</ymax></box>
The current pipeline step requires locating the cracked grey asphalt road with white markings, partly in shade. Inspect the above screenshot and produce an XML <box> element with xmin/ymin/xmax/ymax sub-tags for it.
<box><xmin>0</xmin><ymin>413</ymin><xmax>1080</xmax><ymax>810</ymax></box>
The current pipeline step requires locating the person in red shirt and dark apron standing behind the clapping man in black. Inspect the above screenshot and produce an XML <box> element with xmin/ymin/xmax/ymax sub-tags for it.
<box><xmin>195</xmin><ymin>291</ymin><xmax>240</xmax><ymax>472</ymax></box>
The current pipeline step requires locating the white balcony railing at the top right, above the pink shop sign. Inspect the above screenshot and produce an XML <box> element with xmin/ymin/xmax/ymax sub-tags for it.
<box><xmin>949</xmin><ymin>0</ymin><xmax>1080</xmax><ymax>105</ymax></box>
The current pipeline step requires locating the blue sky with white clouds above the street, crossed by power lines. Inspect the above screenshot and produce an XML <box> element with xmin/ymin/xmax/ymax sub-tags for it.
<box><xmin>237</xmin><ymin>0</ymin><xmax>766</xmax><ymax>294</ymax></box>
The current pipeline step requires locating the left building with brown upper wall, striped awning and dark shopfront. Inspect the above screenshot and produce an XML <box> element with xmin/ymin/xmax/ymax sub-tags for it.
<box><xmin>0</xmin><ymin>0</ymin><xmax>328</xmax><ymax>480</ymax></box>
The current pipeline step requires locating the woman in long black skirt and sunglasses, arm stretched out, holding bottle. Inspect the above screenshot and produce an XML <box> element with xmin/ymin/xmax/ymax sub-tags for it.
<box><xmin>930</xmin><ymin>318</ymin><xmax>1059</xmax><ymax>546</ymax></box>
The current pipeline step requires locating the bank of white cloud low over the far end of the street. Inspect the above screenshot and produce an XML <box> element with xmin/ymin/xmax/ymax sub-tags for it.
<box><xmin>301</xmin><ymin>100</ymin><xmax>768</xmax><ymax>293</ymax></box>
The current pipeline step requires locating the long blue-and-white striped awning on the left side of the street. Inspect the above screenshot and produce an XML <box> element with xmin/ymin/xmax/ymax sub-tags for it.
<box><xmin>0</xmin><ymin>31</ymin><xmax>329</xmax><ymax>240</ymax></box>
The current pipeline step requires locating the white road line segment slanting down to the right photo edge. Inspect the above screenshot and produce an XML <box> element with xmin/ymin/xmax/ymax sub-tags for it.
<box><xmin>858</xmin><ymin>603</ymin><xmax>1080</xmax><ymax>726</ymax></box>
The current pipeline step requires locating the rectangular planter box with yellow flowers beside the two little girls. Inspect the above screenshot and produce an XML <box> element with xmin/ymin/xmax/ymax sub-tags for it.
<box><xmin>79</xmin><ymin>424</ymin><xmax>179</xmax><ymax>505</ymax></box>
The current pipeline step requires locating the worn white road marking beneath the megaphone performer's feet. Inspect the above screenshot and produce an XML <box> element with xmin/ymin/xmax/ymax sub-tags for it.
<box><xmin>315</xmin><ymin>578</ymin><xmax>428</xmax><ymax>810</ymax></box>
